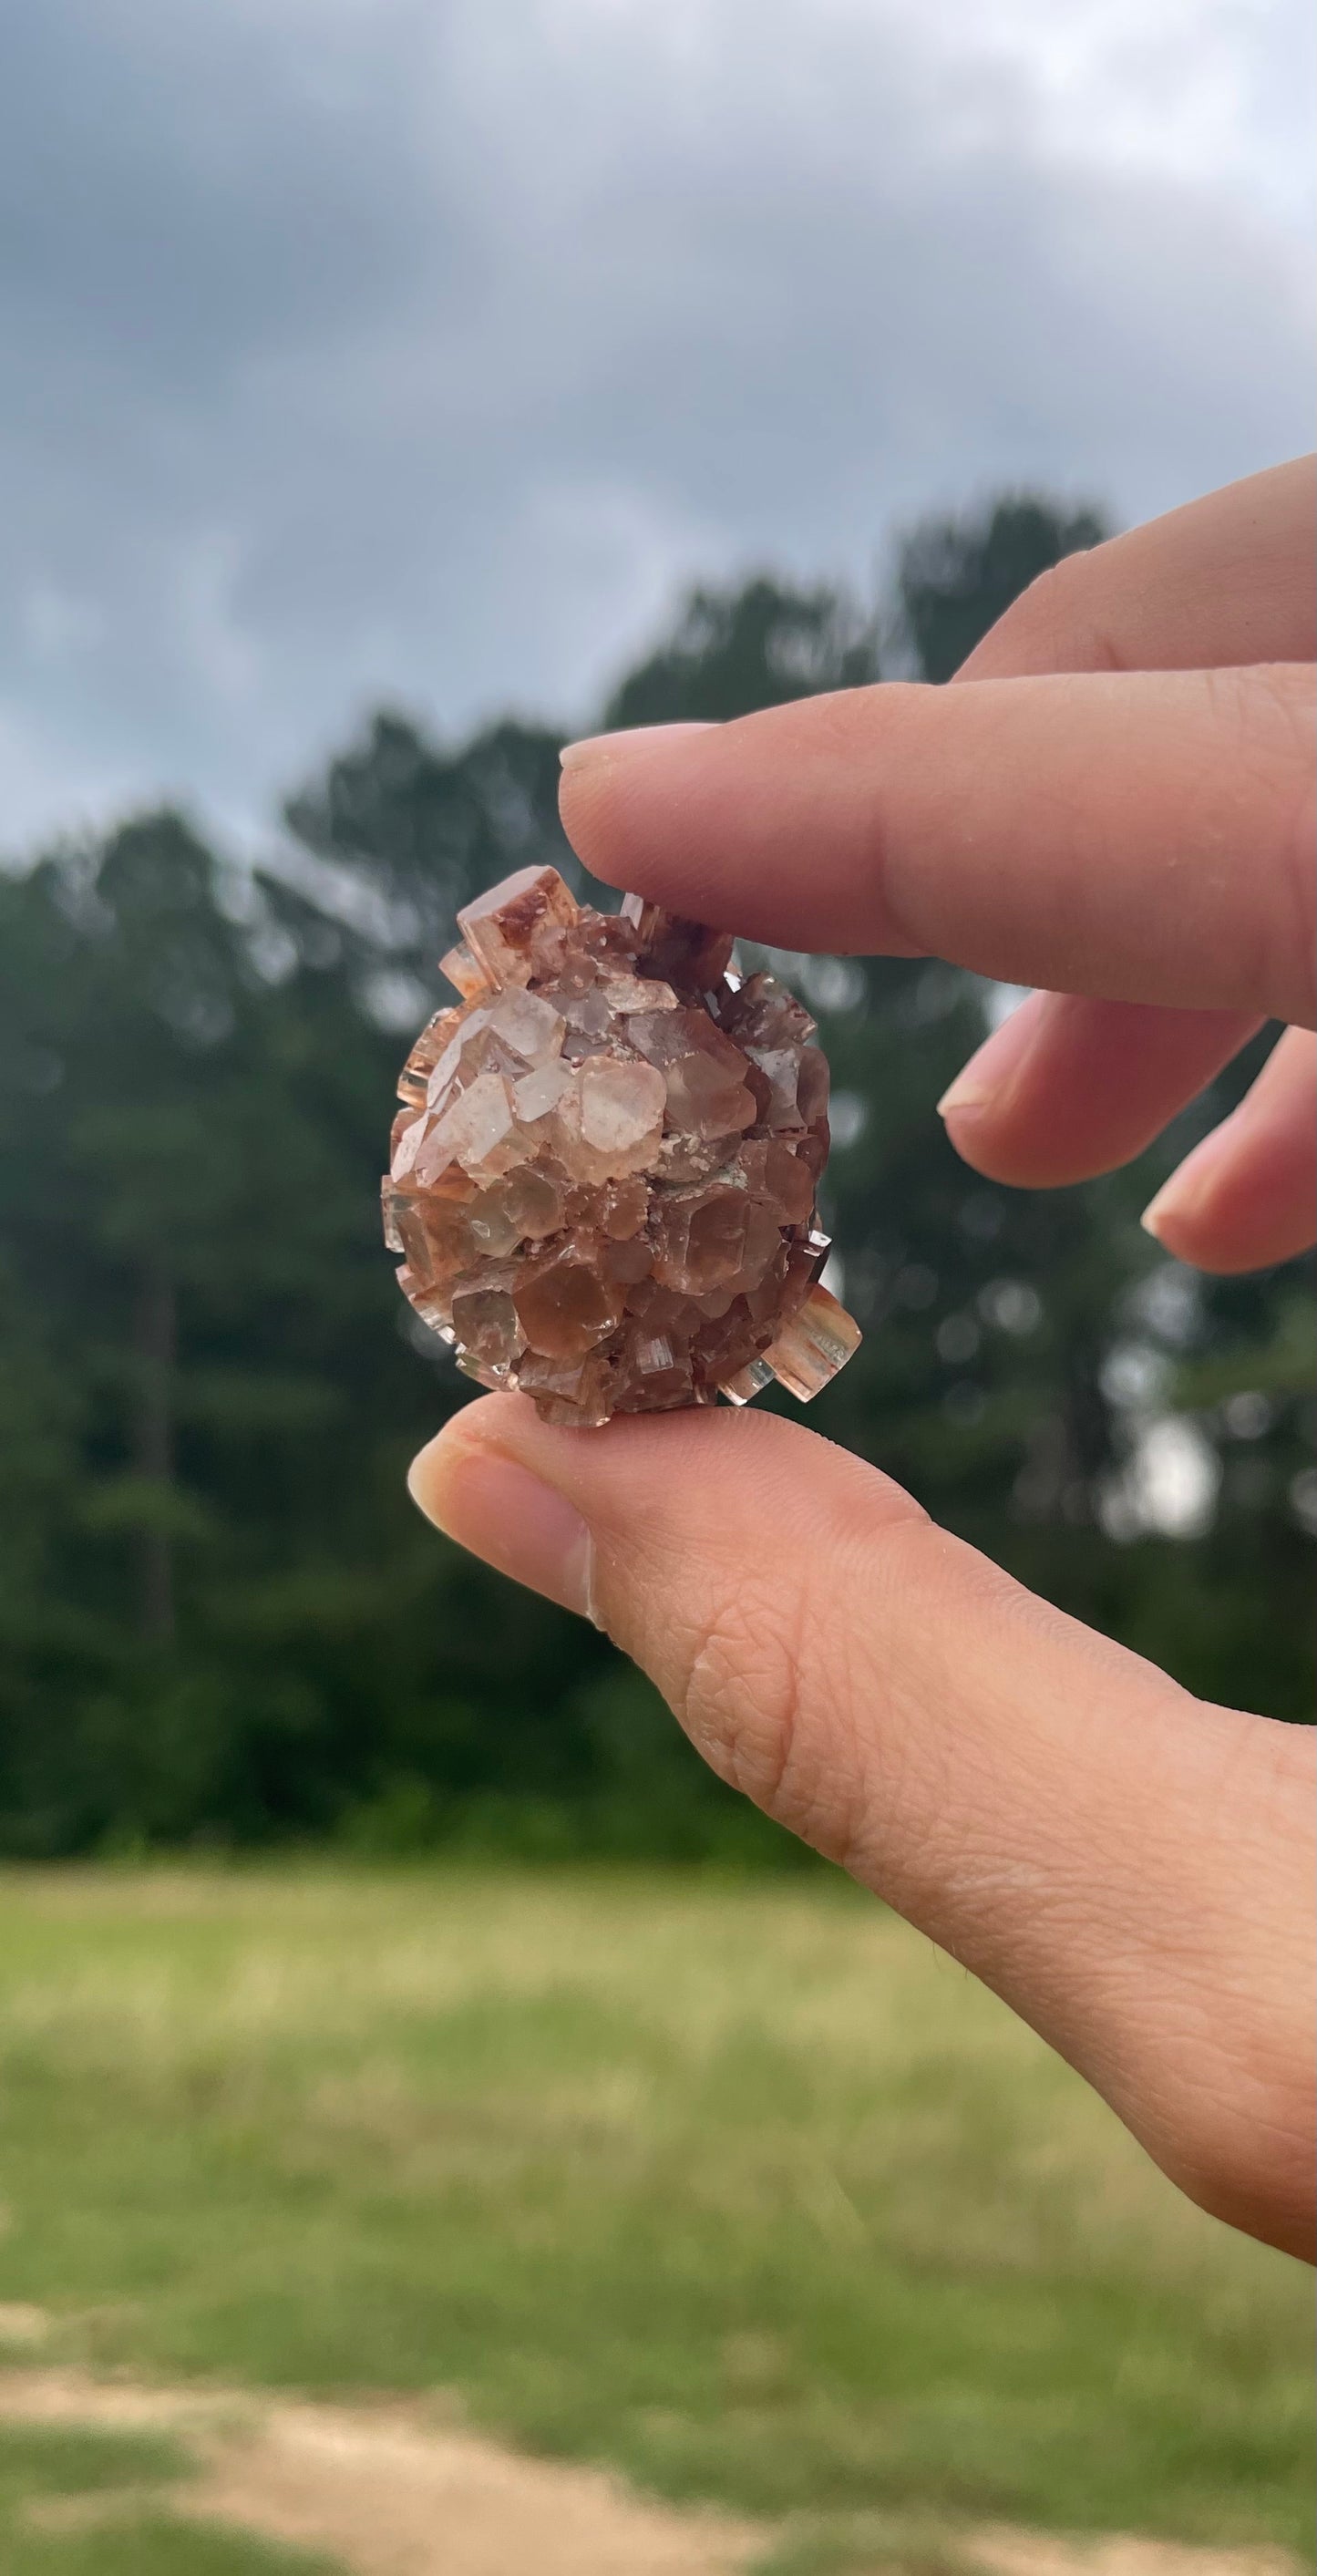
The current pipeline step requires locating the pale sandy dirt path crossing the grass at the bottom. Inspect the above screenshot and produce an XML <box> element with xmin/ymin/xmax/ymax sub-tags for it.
<box><xmin>0</xmin><ymin>2367</ymin><xmax>1294</xmax><ymax>2576</ymax></box>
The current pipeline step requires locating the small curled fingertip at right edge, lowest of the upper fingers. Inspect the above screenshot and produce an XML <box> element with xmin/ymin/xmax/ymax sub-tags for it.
<box><xmin>1145</xmin><ymin>1028</ymin><xmax>1317</xmax><ymax>1270</ymax></box>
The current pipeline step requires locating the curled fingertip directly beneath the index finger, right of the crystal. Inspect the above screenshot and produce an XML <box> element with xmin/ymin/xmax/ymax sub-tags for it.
<box><xmin>938</xmin><ymin>992</ymin><xmax>1258</xmax><ymax>1190</ymax></box>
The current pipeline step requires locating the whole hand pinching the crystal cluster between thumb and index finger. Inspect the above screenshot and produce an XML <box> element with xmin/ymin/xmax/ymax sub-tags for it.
<box><xmin>412</xmin><ymin>464</ymin><xmax>1317</xmax><ymax>2251</ymax></box>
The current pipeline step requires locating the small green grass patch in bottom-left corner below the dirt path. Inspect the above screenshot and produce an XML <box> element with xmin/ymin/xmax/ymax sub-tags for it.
<box><xmin>0</xmin><ymin>2424</ymin><xmax>335</xmax><ymax>2576</ymax></box>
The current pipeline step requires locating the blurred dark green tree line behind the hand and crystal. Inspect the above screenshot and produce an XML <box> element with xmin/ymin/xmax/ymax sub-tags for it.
<box><xmin>0</xmin><ymin>500</ymin><xmax>1317</xmax><ymax>1858</ymax></box>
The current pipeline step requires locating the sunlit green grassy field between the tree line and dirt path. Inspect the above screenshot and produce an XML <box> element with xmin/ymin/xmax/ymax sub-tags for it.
<box><xmin>0</xmin><ymin>1870</ymin><xmax>1312</xmax><ymax>2576</ymax></box>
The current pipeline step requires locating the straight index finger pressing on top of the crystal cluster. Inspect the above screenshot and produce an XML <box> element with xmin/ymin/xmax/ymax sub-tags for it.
<box><xmin>561</xmin><ymin>665</ymin><xmax>1314</xmax><ymax>1023</ymax></box>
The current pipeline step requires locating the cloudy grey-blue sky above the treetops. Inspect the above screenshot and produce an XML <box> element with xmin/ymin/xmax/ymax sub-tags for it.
<box><xmin>0</xmin><ymin>0</ymin><xmax>1312</xmax><ymax>852</ymax></box>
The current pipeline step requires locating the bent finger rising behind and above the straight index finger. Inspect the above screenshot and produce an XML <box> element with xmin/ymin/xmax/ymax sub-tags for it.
<box><xmin>956</xmin><ymin>456</ymin><xmax>1317</xmax><ymax>680</ymax></box>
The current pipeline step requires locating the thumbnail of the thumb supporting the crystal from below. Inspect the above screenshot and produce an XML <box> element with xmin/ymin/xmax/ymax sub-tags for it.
<box><xmin>407</xmin><ymin>1432</ymin><xmax>598</xmax><ymax>1625</ymax></box>
